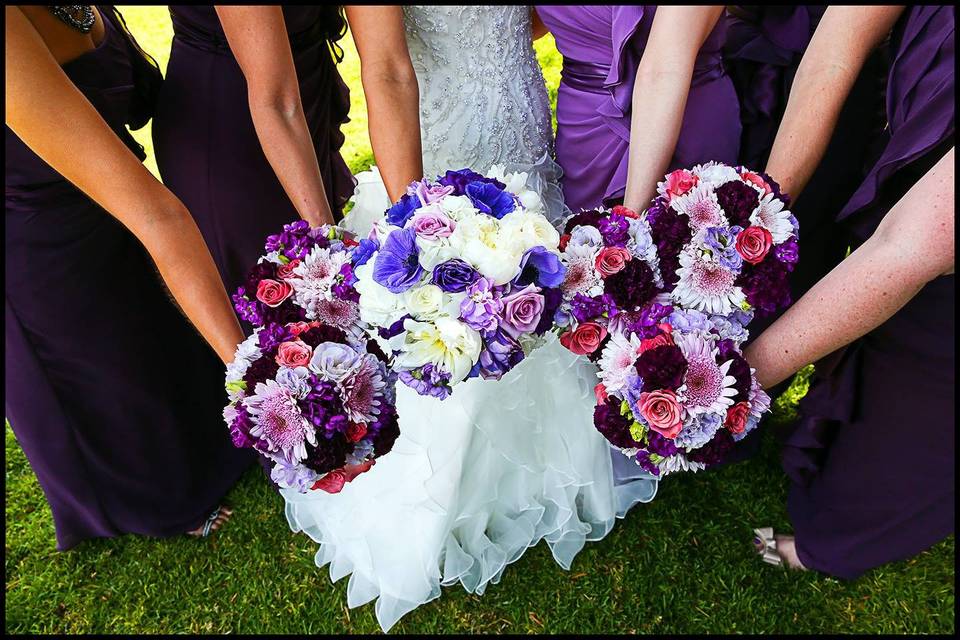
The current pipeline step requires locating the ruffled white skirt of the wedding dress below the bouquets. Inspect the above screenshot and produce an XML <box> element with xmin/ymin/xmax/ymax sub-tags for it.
<box><xmin>282</xmin><ymin>159</ymin><xmax>657</xmax><ymax>631</ymax></box>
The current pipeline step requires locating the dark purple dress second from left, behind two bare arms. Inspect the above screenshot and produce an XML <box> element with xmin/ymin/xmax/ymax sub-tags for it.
<box><xmin>153</xmin><ymin>5</ymin><xmax>354</xmax><ymax>294</ymax></box>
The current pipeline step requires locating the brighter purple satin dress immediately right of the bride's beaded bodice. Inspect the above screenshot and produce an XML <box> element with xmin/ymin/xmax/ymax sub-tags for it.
<box><xmin>537</xmin><ymin>5</ymin><xmax>740</xmax><ymax>211</ymax></box>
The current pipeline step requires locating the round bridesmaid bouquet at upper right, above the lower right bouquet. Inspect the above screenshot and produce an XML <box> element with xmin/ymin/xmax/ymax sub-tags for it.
<box><xmin>646</xmin><ymin>162</ymin><xmax>798</xmax><ymax>316</ymax></box>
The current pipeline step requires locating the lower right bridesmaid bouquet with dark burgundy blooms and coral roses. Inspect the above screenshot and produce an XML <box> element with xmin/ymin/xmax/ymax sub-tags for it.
<box><xmin>594</xmin><ymin>302</ymin><xmax>770</xmax><ymax>476</ymax></box>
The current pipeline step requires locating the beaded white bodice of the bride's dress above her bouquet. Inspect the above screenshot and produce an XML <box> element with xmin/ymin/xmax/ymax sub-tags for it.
<box><xmin>403</xmin><ymin>6</ymin><xmax>553</xmax><ymax>175</ymax></box>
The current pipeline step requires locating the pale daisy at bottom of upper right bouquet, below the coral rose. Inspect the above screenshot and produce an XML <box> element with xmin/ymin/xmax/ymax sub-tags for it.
<box><xmin>672</xmin><ymin>249</ymin><xmax>746</xmax><ymax>315</ymax></box>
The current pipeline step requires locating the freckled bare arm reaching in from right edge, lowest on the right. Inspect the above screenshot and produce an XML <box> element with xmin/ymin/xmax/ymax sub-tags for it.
<box><xmin>744</xmin><ymin>149</ymin><xmax>955</xmax><ymax>387</ymax></box>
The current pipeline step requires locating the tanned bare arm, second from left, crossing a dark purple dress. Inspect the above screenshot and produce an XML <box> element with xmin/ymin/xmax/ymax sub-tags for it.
<box><xmin>216</xmin><ymin>6</ymin><xmax>333</xmax><ymax>226</ymax></box>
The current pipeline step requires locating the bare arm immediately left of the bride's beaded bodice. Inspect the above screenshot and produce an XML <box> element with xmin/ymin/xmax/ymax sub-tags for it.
<box><xmin>347</xmin><ymin>5</ymin><xmax>423</xmax><ymax>201</ymax></box>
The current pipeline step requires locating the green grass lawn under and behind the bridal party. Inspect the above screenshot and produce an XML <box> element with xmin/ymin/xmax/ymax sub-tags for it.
<box><xmin>5</xmin><ymin>7</ymin><xmax>954</xmax><ymax>634</ymax></box>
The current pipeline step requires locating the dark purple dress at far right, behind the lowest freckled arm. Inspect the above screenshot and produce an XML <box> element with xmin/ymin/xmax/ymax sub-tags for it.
<box><xmin>783</xmin><ymin>6</ymin><xmax>956</xmax><ymax>578</ymax></box>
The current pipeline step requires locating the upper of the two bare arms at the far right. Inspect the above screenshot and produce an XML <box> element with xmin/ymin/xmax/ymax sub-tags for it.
<box><xmin>766</xmin><ymin>6</ymin><xmax>904</xmax><ymax>201</ymax></box>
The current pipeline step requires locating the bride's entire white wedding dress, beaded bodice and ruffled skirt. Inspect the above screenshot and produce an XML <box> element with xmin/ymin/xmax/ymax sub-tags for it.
<box><xmin>282</xmin><ymin>6</ymin><xmax>657</xmax><ymax>630</ymax></box>
